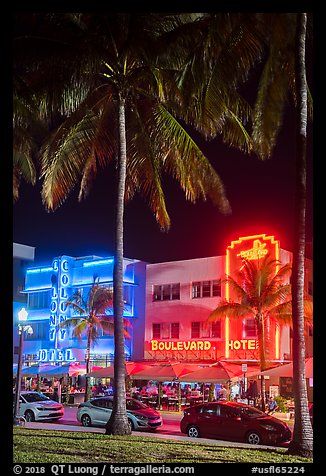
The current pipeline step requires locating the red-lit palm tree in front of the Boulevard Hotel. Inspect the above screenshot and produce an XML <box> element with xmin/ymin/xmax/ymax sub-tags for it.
<box><xmin>208</xmin><ymin>255</ymin><xmax>311</xmax><ymax>410</ymax></box>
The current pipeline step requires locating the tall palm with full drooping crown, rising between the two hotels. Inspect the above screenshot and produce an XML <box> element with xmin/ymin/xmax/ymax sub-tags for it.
<box><xmin>22</xmin><ymin>14</ymin><xmax>230</xmax><ymax>434</ymax></box>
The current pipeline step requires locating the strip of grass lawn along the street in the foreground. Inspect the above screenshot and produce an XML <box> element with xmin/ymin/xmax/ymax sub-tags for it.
<box><xmin>13</xmin><ymin>427</ymin><xmax>312</xmax><ymax>463</ymax></box>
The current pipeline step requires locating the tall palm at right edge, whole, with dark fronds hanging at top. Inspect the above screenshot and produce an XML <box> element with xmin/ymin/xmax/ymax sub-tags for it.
<box><xmin>182</xmin><ymin>13</ymin><xmax>312</xmax><ymax>455</ymax></box>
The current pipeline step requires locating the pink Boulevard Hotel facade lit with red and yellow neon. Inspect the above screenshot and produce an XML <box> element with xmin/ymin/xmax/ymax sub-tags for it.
<box><xmin>144</xmin><ymin>235</ymin><xmax>312</xmax><ymax>362</ymax></box>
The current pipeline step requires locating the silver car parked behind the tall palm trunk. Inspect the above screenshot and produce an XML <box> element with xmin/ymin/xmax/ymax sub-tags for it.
<box><xmin>76</xmin><ymin>396</ymin><xmax>162</xmax><ymax>430</ymax></box>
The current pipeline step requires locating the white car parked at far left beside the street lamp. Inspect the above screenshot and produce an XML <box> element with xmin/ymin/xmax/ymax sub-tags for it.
<box><xmin>13</xmin><ymin>390</ymin><xmax>64</xmax><ymax>421</ymax></box>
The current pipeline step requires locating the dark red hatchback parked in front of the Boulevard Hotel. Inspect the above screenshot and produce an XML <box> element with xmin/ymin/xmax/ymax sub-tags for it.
<box><xmin>180</xmin><ymin>402</ymin><xmax>291</xmax><ymax>445</ymax></box>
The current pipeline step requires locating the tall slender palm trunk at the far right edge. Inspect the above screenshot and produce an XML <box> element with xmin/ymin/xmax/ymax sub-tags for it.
<box><xmin>288</xmin><ymin>13</ymin><xmax>313</xmax><ymax>457</ymax></box>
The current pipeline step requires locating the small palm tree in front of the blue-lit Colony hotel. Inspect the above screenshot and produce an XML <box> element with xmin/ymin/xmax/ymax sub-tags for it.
<box><xmin>59</xmin><ymin>282</ymin><xmax>130</xmax><ymax>401</ymax></box>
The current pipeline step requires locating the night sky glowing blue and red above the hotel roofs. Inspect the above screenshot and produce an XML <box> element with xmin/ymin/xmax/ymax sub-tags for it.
<box><xmin>13</xmin><ymin>104</ymin><xmax>313</xmax><ymax>264</ymax></box>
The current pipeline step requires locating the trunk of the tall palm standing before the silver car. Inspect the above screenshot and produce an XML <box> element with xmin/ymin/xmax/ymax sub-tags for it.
<box><xmin>105</xmin><ymin>97</ymin><xmax>131</xmax><ymax>435</ymax></box>
